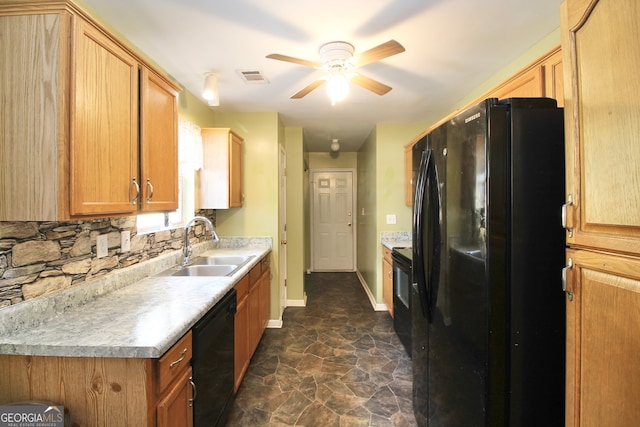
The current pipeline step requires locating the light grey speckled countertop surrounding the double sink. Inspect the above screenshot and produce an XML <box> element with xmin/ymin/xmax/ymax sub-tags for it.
<box><xmin>0</xmin><ymin>241</ymin><xmax>271</xmax><ymax>358</ymax></box>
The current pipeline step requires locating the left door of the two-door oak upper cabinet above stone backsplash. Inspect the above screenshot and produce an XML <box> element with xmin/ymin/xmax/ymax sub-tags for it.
<box><xmin>69</xmin><ymin>17</ymin><xmax>138</xmax><ymax>215</ymax></box>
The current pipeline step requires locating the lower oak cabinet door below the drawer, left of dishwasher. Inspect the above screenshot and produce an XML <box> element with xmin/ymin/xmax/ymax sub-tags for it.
<box><xmin>157</xmin><ymin>367</ymin><xmax>193</xmax><ymax>427</ymax></box>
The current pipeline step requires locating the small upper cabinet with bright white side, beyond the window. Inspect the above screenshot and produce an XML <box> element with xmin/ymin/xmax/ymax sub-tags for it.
<box><xmin>199</xmin><ymin>128</ymin><xmax>244</xmax><ymax>209</ymax></box>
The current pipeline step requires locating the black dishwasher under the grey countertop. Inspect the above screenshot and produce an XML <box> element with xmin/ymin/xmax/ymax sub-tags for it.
<box><xmin>192</xmin><ymin>289</ymin><xmax>236</xmax><ymax>427</ymax></box>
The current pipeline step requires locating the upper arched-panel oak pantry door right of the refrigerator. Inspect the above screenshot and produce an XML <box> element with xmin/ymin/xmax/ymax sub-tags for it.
<box><xmin>561</xmin><ymin>0</ymin><xmax>640</xmax><ymax>255</ymax></box>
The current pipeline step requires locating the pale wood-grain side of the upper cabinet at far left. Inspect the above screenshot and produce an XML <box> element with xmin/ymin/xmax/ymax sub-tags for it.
<box><xmin>0</xmin><ymin>12</ymin><xmax>71</xmax><ymax>221</ymax></box>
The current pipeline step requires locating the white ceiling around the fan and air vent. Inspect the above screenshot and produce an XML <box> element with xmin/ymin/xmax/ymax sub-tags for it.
<box><xmin>79</xmin><ymin>0</ymin><xmax>561</xmax><ymax>151</ymax></box>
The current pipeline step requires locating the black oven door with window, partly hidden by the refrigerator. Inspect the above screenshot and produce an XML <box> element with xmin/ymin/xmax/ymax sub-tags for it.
<box><xmin>391</xmin><ymin>251</ymin><xmax>412</xmax><ymax>357</ymax></box>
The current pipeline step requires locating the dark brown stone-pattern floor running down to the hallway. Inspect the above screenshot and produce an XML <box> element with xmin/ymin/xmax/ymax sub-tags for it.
<box><xmin>227</xmin><ymin>273</ymin><xmax>416</xmax><ymax>427</ymax></box>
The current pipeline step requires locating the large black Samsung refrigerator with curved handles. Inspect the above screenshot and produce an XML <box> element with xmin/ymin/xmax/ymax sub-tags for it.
<box><xmin>411</xmin><ymin>98</ymin><xmax>565</xmax><ymax>427</ymax></box>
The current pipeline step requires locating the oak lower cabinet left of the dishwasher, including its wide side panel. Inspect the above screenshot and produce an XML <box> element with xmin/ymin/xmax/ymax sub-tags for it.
<box><xmin>0</xmin><ymin>332</ymin><xmax>193</xmax><ymax>427</ymax></box>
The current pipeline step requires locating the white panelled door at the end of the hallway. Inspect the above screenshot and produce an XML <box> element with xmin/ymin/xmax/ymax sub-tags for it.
<box><xmin>311</xmin><ymin>170</ymin><xmax>355</xmax><ymax>271</ymax></box>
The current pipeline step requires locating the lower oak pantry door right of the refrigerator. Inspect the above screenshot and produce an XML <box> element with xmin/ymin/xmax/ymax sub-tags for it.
<box><xmin>566</xmin><ymin>250</ymin><xmax>640</xmax><ymax>427</ymax></box>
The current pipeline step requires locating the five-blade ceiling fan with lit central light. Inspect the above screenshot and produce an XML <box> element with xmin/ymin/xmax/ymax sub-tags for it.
<box><xmin>267</xmin><ymin>40</ymin><xmax>405</xmax><ymax>105</ymax></box>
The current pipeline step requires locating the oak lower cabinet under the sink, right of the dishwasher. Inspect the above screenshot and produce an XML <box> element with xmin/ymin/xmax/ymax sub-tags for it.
<box><xmin>234</xmin><ymin>255</ymin><xmax>271</xmax><ymax>391</ymax></box>
